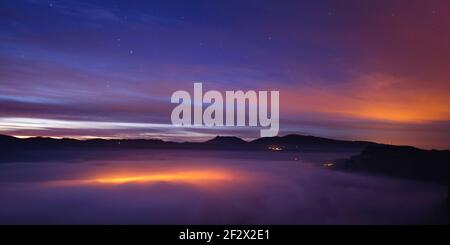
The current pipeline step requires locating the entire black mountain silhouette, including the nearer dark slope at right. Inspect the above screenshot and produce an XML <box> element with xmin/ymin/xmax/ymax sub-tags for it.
<box><xmin>0</xmin><ymin>134</ymin><xmax>450</xmax><ymax>186</ymax></box>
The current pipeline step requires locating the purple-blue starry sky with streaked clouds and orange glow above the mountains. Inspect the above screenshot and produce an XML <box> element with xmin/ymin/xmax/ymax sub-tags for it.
<box><xmin>0</xmin><ymin>0</ymin><xmax>450</xmax><ymax>149</ymax></box>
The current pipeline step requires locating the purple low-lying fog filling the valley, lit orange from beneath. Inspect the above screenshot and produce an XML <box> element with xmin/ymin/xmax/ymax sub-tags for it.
<box><xmin>0</xmin><ymin>150</ymin><xmax>447</xmax><ymax>224</ymax></box>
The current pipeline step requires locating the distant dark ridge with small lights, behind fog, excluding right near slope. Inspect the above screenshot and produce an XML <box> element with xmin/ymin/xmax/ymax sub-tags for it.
<box><xmin>0</xmin><ymin>135</ymin><xmax>376</xmax><ymax>162</ymax></box>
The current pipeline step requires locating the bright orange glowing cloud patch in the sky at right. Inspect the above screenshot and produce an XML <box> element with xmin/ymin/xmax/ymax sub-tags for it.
<box><xmin>280</xmin><ymin>74</ymin><xmax>450</xmax><ymax>123</ymax></box>
